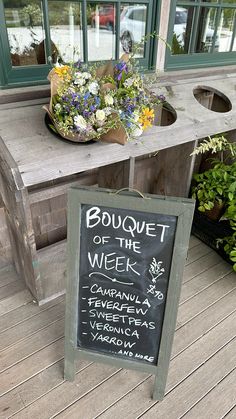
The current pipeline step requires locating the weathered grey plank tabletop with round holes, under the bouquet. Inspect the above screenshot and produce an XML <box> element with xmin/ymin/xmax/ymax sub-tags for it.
<box><xmin>0</xmin><ymin>75</ymin><xmax>236</xmax><ymax>187</ymax></box>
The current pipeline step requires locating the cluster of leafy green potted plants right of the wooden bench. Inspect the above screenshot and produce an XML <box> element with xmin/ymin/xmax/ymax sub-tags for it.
<box><xmin>192</xmin><ymin>135</ymin><xmax>236</xmax><ymax>270</ymax></box>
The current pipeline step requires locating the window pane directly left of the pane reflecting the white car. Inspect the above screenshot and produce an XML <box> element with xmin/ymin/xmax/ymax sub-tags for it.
<box><xmin>87</xmin><ymin>3</ymin><xmax>116</xmax><ymax>61</ymax></box>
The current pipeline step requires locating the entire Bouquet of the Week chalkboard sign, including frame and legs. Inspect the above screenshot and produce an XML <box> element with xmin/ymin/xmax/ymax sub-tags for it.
<box><xmin>64</xmin><ymin>187</ymin><xmax>195</xmax><ymax>400</ymax></box>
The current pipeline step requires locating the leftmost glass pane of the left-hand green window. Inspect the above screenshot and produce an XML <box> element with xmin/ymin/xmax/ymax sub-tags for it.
<box><xmin>4</xmin><ymin>0</ymin><xmax>46</xmax><ymax>66</ymax></box>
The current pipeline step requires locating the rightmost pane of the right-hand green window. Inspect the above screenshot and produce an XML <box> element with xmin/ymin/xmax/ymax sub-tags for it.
<box><xmin>217</xmin><ymin>9</ymin><xmax>236</xmax><ymax>52</ymax></box>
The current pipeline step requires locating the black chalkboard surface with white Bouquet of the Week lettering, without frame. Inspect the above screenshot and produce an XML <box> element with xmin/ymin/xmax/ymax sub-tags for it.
<box><xmin>77</xmin><ymin>205</ymin><xmax>177</xmax><ymax>364</ymax></box>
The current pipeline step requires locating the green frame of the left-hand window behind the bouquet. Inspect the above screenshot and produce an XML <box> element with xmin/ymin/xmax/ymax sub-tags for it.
<box><xmin>0</xmin><ymin>0</ymin><xmax>161</xmax><ymax>89</ymax></box>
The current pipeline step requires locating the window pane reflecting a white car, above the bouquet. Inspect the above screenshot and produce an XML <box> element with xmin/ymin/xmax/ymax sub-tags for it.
<box><xmin>120</xmin><ymin>3</ymin><xmax>147</xmax><ymax>57</ymax></box>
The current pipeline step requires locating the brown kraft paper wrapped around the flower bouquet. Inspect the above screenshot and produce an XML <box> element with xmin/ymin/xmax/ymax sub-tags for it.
<box><xmin>43</xmin><ymin>54</ymin><xmax>129</xmax><ymax>145</ymax></box>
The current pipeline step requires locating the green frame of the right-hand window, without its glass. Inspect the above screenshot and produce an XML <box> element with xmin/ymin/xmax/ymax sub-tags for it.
<box><xmin>165</xmin><ymin>0</ymin><xmax>236</xmax><ymax>71</ymax></box>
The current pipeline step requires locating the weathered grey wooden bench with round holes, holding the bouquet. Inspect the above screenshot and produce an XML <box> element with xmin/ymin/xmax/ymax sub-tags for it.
<box><xmin>0</xmin><ymin>73</ymin><xmax>236</xmax><ymax>304</ymax></box>
